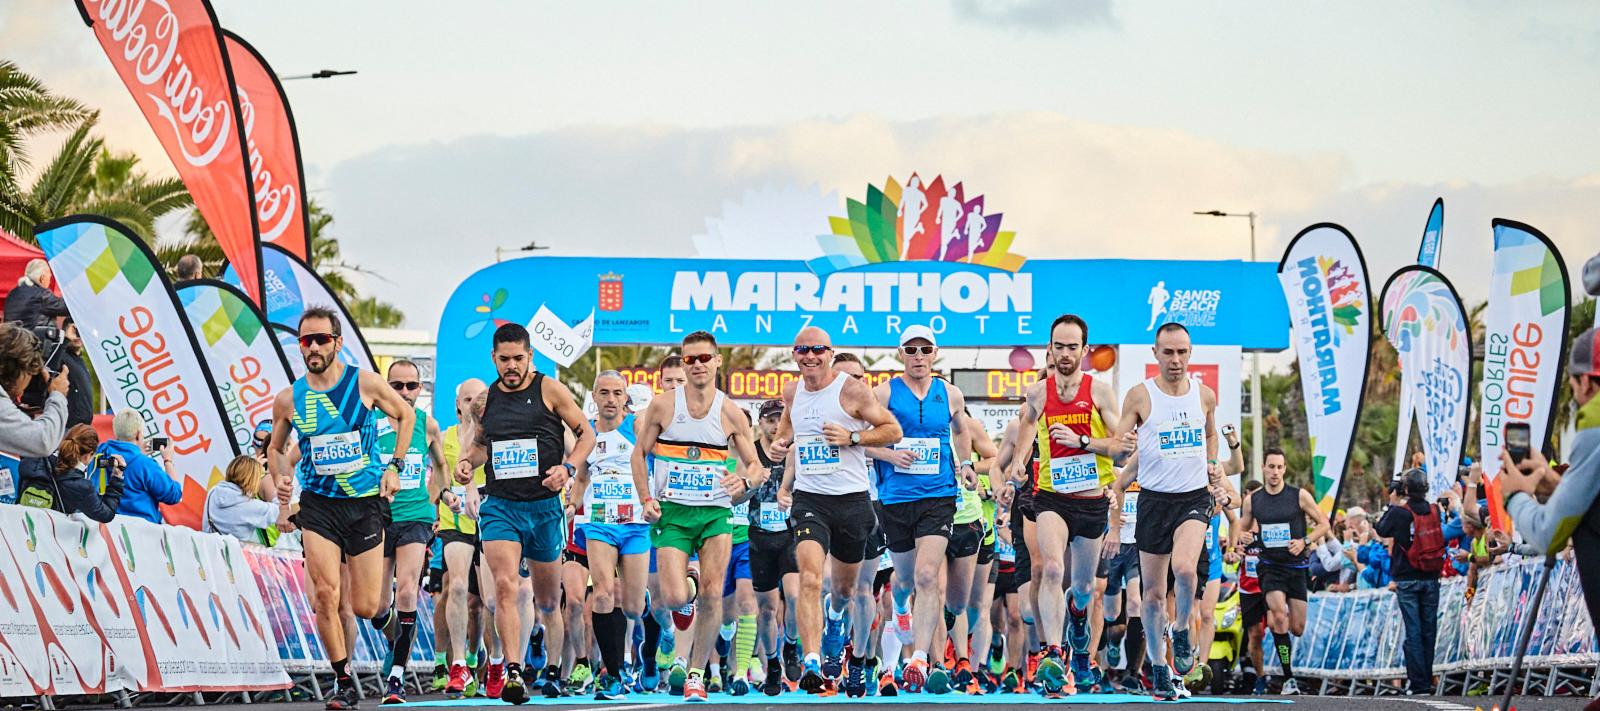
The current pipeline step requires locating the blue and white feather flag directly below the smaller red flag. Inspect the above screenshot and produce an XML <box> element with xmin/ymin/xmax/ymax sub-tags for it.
<box><xmin>222</xmin><ymin>245</ymin><xmax>376</xmax><ymax>370</ymax></box>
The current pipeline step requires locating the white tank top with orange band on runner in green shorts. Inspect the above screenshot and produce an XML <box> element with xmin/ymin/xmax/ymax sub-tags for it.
<box><xmin>653</xmin><ymin>386</ymin><xmax>733</xmax><ymax>508</ymax></box>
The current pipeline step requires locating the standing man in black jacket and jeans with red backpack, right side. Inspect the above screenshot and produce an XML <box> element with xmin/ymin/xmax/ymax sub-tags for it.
<box><xmin>1374</xmin><ymin>469</ymin><xmax>1443</xmax><ymax>695</ymax></box>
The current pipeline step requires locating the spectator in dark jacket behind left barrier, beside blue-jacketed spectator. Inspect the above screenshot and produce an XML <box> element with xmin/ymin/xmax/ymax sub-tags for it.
<box><xmin>18</xmin><ymin>424</ymin><xmax>126</xmax><ymax>524</ymax></box>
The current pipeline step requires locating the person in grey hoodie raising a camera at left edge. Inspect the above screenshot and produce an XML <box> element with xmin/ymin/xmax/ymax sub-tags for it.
<box><xmin>0</xmin><ymin>323</ymin><xmax>69</xmax><ymax>458</ymax></box>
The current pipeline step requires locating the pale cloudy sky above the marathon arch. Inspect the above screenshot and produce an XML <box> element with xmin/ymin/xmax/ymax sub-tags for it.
<box><xmin>0</xmin><ymin>0</ymin><xmax>1600</xmax><ymax>339</ymax></box>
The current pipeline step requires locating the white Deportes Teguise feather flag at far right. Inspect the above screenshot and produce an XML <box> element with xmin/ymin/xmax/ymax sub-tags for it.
<box><xmin>1478</xmin><ymin>219</ymin><xmax>1571</xmax><ymax>532</ymax></box>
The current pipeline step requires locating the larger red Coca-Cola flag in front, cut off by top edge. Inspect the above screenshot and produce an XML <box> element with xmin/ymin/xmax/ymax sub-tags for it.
<box><xmin>77</xmin><ymin>0</ymin><xmax>262</xmax><ymax>303</ymax></box>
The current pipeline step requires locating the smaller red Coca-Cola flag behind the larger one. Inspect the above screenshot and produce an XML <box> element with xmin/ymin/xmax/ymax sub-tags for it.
<box><xmin>222</xmin><ymin>30</ymin><xmax>310</xmax><ymax>259</ymax></box>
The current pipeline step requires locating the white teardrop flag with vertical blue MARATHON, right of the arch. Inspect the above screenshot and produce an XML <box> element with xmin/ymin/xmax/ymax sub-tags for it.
<box><xmin>1278</xmin><ymin>223</ymin><xmax>1373</xmax><ymax>514</ymax></box>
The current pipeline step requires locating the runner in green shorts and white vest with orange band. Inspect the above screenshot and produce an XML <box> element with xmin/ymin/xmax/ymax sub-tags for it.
<box><xmin>632</xmin><ymin>331</ymin><xmax>766</xmax><ymax>701</ymax></box>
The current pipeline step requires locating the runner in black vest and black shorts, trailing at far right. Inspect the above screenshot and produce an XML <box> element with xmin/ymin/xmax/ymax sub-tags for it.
<box><xmin>1234</xmin><ymin>447</ymin><xmax>1333</xmax><ymax>695</ymax></box>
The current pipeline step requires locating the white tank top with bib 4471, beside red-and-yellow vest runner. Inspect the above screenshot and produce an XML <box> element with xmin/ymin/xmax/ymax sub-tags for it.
<box><xmin>1139</xmin><ymin>378</ymin><xmax>1210</xmax><ymax>493</ymax></box>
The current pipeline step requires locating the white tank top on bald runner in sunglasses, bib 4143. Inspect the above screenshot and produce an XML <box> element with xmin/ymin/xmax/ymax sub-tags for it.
<box><xmin>790</xmin><ymin>373</ymin><xmax>870</xmax><ymax>495</ymax></box>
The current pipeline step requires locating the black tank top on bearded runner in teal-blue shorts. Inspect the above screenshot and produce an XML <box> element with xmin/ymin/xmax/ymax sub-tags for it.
<box><xmin>478</xmin><ymin>373</ymin><xmax>566</xmax><ymax>501</ymax></box>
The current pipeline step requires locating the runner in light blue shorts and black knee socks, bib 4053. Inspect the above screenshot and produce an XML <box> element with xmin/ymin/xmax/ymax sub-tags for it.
<box><xmin>574</xmin><ymin>370</ymin><xmax>650</xmax><ymax>701</ymax></box>
